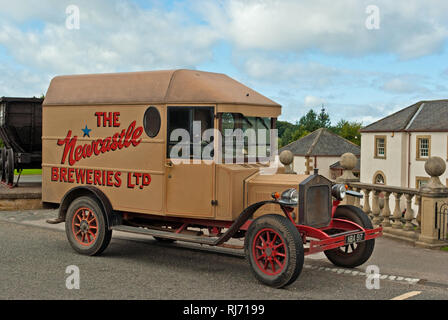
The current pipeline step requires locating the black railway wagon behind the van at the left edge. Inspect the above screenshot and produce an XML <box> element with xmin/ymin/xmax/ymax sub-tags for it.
<box><xmin>0</xmin><ymin>97</ymin><xmax>44</xmax><ymax>185</ymax></box>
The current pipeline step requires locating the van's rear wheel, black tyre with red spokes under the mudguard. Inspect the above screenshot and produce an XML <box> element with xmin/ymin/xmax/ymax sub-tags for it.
<box><xmin>65</xmin><ymin>196</ymin><xmax>112</xmax><ymax>256</ymax></box>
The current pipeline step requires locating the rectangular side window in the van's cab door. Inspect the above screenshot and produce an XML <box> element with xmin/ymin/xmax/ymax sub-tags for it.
<box><xmin>167</xmin><ymin>107</ymin><xmax>214</xmax><ymax>160</ymax></box>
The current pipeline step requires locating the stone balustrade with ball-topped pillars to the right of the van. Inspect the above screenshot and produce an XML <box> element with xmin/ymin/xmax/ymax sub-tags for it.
<box><xmin>336</xmin><ymin>154</ymin><xmax>448</xmax><ymax>247</ymax></box>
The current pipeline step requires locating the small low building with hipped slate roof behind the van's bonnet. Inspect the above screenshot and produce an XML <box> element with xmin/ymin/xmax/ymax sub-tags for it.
<box><xmin>279</xmin><ymin>128</ymin><xmax>361</xmax><ymax>179</ymax></box>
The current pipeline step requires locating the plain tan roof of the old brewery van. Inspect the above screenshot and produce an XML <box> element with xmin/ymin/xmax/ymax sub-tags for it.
<box><xmin>44</xmin><ymin>69</ymin><xmax>281</xmax><ymax>108</ymax></box>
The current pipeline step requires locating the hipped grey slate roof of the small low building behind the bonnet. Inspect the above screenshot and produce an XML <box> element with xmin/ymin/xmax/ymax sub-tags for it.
<box><xmin>279</xmin><ymin>128</ymin><xmax>361</xmax><ymax>156</ymax></box>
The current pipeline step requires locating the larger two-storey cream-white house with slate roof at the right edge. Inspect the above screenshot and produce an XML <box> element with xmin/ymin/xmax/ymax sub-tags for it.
<box><xmin>360</xmin><ymin>100</ymin><xmax>448</xmax><ymax>188</ymax></box>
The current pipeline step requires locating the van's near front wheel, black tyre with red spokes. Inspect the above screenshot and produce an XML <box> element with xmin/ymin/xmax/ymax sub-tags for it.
<box><xmin>244</xmin><ymin>214</ymin><xmax>304</xmax><ymax>288</ymax></box>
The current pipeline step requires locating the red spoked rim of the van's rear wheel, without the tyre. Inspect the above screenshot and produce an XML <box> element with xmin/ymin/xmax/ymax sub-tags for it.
<box><xmin>72</xmin><ymin>208</ymin><xmax>98</xmax><ymax>246</ymax></box>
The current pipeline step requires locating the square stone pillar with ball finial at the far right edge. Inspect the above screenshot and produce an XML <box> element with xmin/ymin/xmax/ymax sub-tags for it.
<box><xmin>416</xmin><ymin>157</ymin><xmax>448</xmax><ymax>247</ymax></box>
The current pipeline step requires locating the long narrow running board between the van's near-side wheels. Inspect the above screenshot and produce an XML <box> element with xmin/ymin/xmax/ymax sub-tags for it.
<box><xmin>112</xmin><ymin>225</ymin><xmax>219</xmax><ymax>246</ymax></box>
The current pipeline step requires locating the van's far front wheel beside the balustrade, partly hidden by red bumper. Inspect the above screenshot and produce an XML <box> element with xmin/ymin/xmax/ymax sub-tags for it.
<box><xmin>324</xmin><ymin>205</ymin><xmax>375</xmax><ymax>268</ymax></box>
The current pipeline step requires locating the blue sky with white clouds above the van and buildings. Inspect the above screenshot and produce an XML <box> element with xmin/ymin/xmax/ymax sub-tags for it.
<box><xmin>0</xmin><ymin>0</ymin><xmax>448</xmax><ymax>125</ymax></box>
